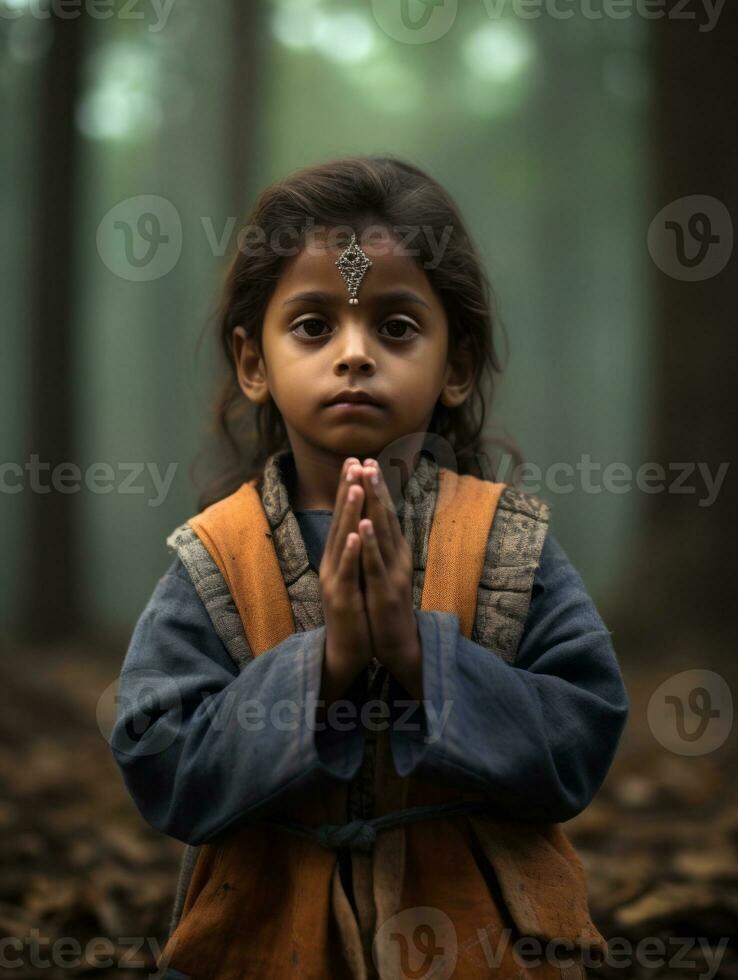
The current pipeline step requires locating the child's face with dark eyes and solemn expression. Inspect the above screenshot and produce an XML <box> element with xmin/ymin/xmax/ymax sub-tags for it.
<box><xmin>234</xmin><ymin>235</ymin><xmax>471</xmax><ymax>459</ymax></box>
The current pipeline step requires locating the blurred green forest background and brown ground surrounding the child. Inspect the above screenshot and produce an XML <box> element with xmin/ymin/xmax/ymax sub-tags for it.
<box><xmin>0</xmin><ymin>0</ymin><xmax>738</xmax><ymax>978</ymax></box>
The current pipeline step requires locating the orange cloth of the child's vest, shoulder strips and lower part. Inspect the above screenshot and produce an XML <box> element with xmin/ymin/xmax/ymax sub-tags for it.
<box><xmin>159</xmin><ymin>469</ymin><xmax>606</xmax><ymax>980</ymax></box>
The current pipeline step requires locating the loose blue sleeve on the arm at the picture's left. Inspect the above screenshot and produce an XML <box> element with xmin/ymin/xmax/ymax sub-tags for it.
<box><xmin>110</xmin><ymin>558</ymin><xmax>365</xmax><ymax>844</ymax></box>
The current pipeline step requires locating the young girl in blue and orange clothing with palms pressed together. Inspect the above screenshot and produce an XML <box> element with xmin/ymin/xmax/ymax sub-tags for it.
<box><xmin>111</xmin><ymin>157</ymin><xmax>628</xmax><ymax>980</ymax></box>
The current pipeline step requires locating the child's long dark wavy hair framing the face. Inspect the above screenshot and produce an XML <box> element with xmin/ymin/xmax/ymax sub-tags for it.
<box><xmin>191</xmin><ymin>155</ymin><xmax>522</xmax><ymax>510</ymax></box>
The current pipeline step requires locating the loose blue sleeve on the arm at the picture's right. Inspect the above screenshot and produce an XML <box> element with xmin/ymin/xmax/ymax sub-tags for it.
<box><xmin>390</xmin><ymin>533</ymin><xmax>629</xmax><ymax>822</ymax></box>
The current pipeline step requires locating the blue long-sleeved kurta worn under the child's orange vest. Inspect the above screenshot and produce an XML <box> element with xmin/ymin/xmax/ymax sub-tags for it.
<box><xmin>111</xmin><ymin>511</ymin><xmax>629</xmax><ymax>845</ymax></box>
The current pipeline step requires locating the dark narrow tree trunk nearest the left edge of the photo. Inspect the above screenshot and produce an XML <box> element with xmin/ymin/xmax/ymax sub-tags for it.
<box><xmin>19</xmin><ymin>14</ymin><xmax>87</xmax><ymax>640</ymax></box>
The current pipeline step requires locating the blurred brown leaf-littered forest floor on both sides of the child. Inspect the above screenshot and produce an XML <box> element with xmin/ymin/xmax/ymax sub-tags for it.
<box><xmin>0</xmin><ymin>632</ymin><xmax>738</xmax><ymax>980</ymax></box>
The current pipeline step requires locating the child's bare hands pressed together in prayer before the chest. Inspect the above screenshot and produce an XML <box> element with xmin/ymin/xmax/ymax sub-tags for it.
<box><xmin>320</xmin><ymin>457</ymin><xmax>422</xmax><ymax>702</ymax></box>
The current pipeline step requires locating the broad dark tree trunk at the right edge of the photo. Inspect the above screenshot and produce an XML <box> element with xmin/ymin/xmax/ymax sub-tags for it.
<box><xmin>617</xmin><ymin>4</ymin><xmax>738</xmax><ymax>663</ymax></box>
